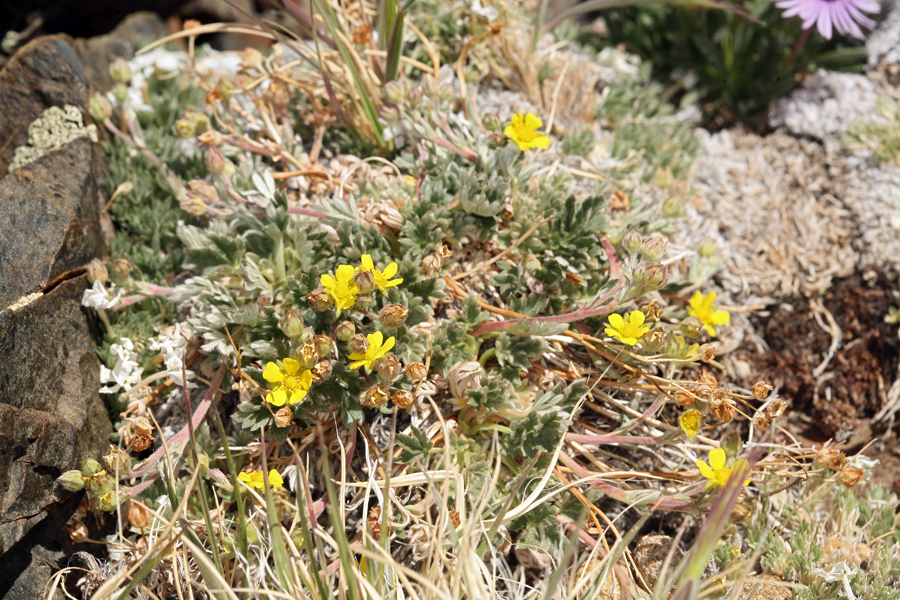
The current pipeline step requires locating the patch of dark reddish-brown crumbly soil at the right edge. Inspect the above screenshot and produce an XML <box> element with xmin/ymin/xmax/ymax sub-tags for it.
<box><xmin>741</xmin><ymin>275</ymin><xmax>900</xmax><ymax>491</ymax></box>
